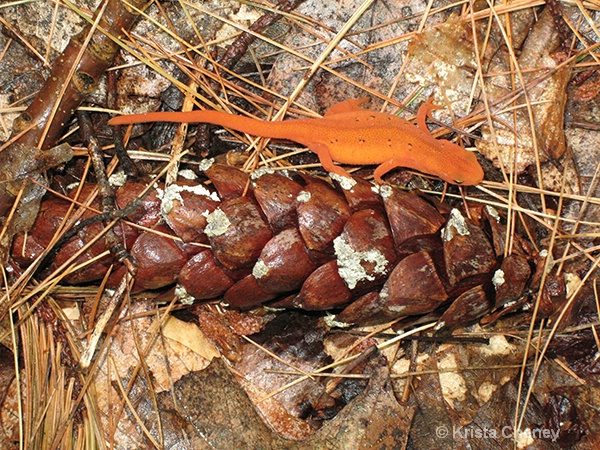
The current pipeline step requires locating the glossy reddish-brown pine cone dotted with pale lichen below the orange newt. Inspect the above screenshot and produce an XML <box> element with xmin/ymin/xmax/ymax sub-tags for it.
<box><xmin>12</xmin><ymin>164</ymin><xmax>561</xmax><ymax>327</ymax></box>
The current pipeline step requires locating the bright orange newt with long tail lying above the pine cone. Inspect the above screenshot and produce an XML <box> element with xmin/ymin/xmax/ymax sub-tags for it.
<box><xmin>108</xmin><ymin>98</ymin><xmax>483</xmax><ymax>185</ymax></box>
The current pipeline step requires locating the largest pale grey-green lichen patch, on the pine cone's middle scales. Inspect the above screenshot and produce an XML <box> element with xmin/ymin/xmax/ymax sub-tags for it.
<box><xmin>333</xmin><ymin>236</ymin><xmax>389</xmax><ymax>289</ymax></box>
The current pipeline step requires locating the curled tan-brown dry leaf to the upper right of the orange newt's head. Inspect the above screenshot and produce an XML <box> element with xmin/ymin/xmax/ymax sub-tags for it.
<box><xmin>476</xmin><ymin>8</ymin><xmax>571</xmax><ymax>173</ymax></box>
